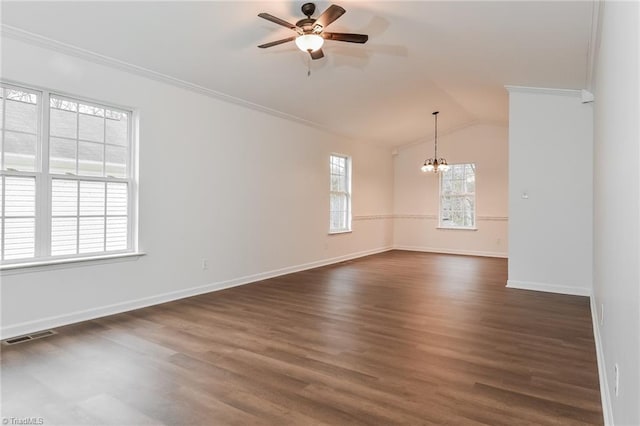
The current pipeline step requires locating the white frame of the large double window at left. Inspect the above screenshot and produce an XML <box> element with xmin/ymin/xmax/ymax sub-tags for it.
<box><xmin>0</xmin><ymin>79</ymin><xmax>143</xmax><ymax>270</ymax></box>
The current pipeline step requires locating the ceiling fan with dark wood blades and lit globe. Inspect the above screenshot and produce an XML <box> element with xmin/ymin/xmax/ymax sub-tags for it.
<box><xmin>258</xmin><ymin>3</ymin><xmax>369</xmax><ymax>59</ymax></box>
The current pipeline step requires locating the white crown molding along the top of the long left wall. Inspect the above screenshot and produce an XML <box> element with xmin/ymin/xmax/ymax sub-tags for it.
<box><xmin>0</xmin><ymin>24</ymin><xmax>357</xmax><ymax>145</ymax></box>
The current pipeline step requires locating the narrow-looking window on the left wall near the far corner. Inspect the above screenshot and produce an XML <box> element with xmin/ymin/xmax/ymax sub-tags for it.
<box><xmin>329</xmin><ymin>155</ymin><xmax>351</xmax><ymax>233</ymax></box>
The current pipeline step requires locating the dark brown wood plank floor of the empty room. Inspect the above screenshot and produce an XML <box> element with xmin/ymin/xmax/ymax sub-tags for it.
<box><xmin>1</xmin><ymin>251</ymin><xmax>602</xmax><ymax>426</ymax></box>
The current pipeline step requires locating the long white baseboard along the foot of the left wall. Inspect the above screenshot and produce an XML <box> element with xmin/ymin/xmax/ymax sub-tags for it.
<box><xmin>0</xmin><ymin>247</ymin><xmax>393</xmax><ymax>340</ymax></box>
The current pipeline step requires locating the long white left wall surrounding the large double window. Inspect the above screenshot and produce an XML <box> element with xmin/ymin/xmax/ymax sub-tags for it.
<box><xmin>1</xmin><ymin>38</ymin><xmax>393</xmax><ymax>337</ymax></box>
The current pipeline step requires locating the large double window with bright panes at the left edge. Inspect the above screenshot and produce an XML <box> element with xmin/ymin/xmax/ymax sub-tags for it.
<box><xmin>0</xmin><ymin>84</ymin><xmax>135</xmax><ymax>264</ymax></box>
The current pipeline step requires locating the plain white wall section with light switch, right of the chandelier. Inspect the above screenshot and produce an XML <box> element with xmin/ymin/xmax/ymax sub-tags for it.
<box><xmin>508</xmin><ymin>88</ymin><xmax>593</xmax><ymax>295</ymax></box>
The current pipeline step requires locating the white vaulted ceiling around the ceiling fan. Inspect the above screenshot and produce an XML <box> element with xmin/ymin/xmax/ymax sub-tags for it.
<box><xmin>2</xmin><ymin>0</ymin><xmax>592</xmax><ymax>147</ymax></box>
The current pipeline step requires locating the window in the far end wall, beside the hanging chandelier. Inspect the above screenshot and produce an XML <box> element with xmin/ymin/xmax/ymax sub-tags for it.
<box><xmin>440</xmin><ymin>163</ymin><xmax>476</xmax><ymax>229</ymax></box>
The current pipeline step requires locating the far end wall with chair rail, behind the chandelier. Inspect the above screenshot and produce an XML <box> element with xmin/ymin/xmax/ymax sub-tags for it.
<box><xmin>394</xmin><ymin>124</ymin><xmax>508</xmax><ymax>257</ymax></box>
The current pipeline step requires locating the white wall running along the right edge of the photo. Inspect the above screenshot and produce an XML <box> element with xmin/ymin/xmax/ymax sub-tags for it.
<box><xmin>592</xmin><ymin>2</ymin><xmax>640</xmax><ymax>426</ymax></box>
